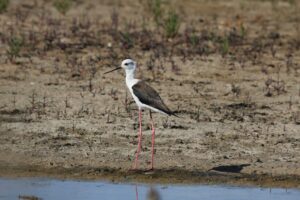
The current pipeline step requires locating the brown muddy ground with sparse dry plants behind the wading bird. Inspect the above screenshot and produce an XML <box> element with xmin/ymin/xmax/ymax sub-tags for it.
<box><xmin>0</xmin><ymin>0</ymin><xmax>300</xmax><ymax>187</ymax></box>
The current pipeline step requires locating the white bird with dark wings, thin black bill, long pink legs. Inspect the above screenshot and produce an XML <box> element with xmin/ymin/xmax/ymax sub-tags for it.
<box><xmin>104</xmin><ymin>59</ymin><xmax>176</xmax><ymax>169</ymax></box>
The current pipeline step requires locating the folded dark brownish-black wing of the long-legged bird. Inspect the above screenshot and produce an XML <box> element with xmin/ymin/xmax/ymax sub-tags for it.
<box><xmin>132</xmin><ymin>81</ymin><xmax>174</xmax><ymax>115</ymax></box>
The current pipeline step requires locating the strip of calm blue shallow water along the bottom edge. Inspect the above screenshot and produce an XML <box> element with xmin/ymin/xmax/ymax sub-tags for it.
<box><xmin>0</xmin><ymin>178</ymin><xmax>300</xmax><ymax>200</ymax></box>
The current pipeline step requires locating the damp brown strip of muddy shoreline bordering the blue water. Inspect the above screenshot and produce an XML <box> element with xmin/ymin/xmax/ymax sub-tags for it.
<box><xmin>0</xmin><ymin>166</ymin><xmax>300</xmax><ymax>189</ymax></box>
